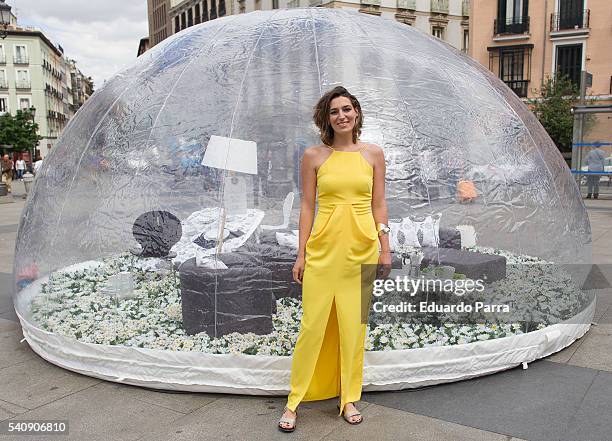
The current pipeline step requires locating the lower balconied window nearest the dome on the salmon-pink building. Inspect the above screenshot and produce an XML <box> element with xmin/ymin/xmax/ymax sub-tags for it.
<box><xmin>487</xmin><ymin>44</ymin><xmax>533</xmax><ymax>98</ymax></box>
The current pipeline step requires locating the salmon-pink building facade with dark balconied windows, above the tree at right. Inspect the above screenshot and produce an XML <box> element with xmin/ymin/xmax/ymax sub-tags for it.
<box><xmin>469</xmin><ymin>0</ymin><xmax>612</xmax><ymax>101</ymax></box>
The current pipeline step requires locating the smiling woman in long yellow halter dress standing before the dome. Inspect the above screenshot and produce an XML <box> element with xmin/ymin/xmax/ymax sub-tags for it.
<box><xmin>278</xmin><ymin>86</ymin><xmax>391</xmax><ymax>432</ymax></box>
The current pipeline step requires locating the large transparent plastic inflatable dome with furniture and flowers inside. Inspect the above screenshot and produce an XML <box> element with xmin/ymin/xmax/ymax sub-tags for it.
<box><xmin>14</xmin><ymin>8</ymin><xmax>593</xmax><ymax>393</ymax></box>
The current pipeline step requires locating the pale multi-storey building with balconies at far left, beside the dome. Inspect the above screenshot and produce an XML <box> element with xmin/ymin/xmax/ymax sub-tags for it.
<box><xmin>0</xmin><ymin>2</ymin><xmax>93</xmax><ymax>157</ymax></box>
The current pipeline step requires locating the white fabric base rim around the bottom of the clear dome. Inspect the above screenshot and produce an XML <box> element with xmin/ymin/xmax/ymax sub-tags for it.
<box><xmin>17</xmin><ymin>264</ymin><xmax>596</xmax><ymax>395</ymax></box>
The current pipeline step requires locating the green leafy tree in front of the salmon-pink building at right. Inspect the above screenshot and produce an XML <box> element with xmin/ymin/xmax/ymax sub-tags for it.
<box><xmin>529</xmin><ymin>75</ymin><xmax>580</xmax><ymax>152</ymax></box>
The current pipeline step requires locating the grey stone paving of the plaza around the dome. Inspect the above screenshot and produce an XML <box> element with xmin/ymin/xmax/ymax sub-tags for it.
<box><xmin>0</xmin><ymin>183</ymin><xmax>612</xmax><ymax>441</ymax></box>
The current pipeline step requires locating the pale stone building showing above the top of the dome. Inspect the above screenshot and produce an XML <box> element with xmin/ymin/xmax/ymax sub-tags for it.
<box><xmin>148</xmin><ymin>0</ymin><xmax>469</xmax><ymax>52</ymax></box>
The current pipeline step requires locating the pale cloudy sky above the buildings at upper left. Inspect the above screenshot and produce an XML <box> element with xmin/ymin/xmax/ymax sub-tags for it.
<box><xmin>6</xmin><ymin>0</ymin><xmax>149</xmax><ymax>88</ymax></box>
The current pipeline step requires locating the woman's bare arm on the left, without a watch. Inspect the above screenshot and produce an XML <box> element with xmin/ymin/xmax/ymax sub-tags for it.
<box><xmin>293</xmin><ymin>147</ymin><xmax>318</xmax><ymax>283</ymax></box>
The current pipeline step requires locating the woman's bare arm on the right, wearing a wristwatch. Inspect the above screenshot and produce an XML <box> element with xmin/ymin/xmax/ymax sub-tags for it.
<box><xmin>370</xmin><ymin>144</ymin><xmax>391</xmax><ymax>267</ymax></box>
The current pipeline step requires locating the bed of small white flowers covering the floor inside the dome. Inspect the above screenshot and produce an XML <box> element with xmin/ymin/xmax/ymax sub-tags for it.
<box><xmin>31</xmin><ymin>247</ymin><xmax>585</xmax><ymax>355</ymax></box>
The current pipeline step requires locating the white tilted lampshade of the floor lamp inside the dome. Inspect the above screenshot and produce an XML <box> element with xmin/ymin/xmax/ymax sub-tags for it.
<box><xmin>202</xmin><ymin>135</ymin><xmax>257</xmax><ymax>175</ymax></box>
